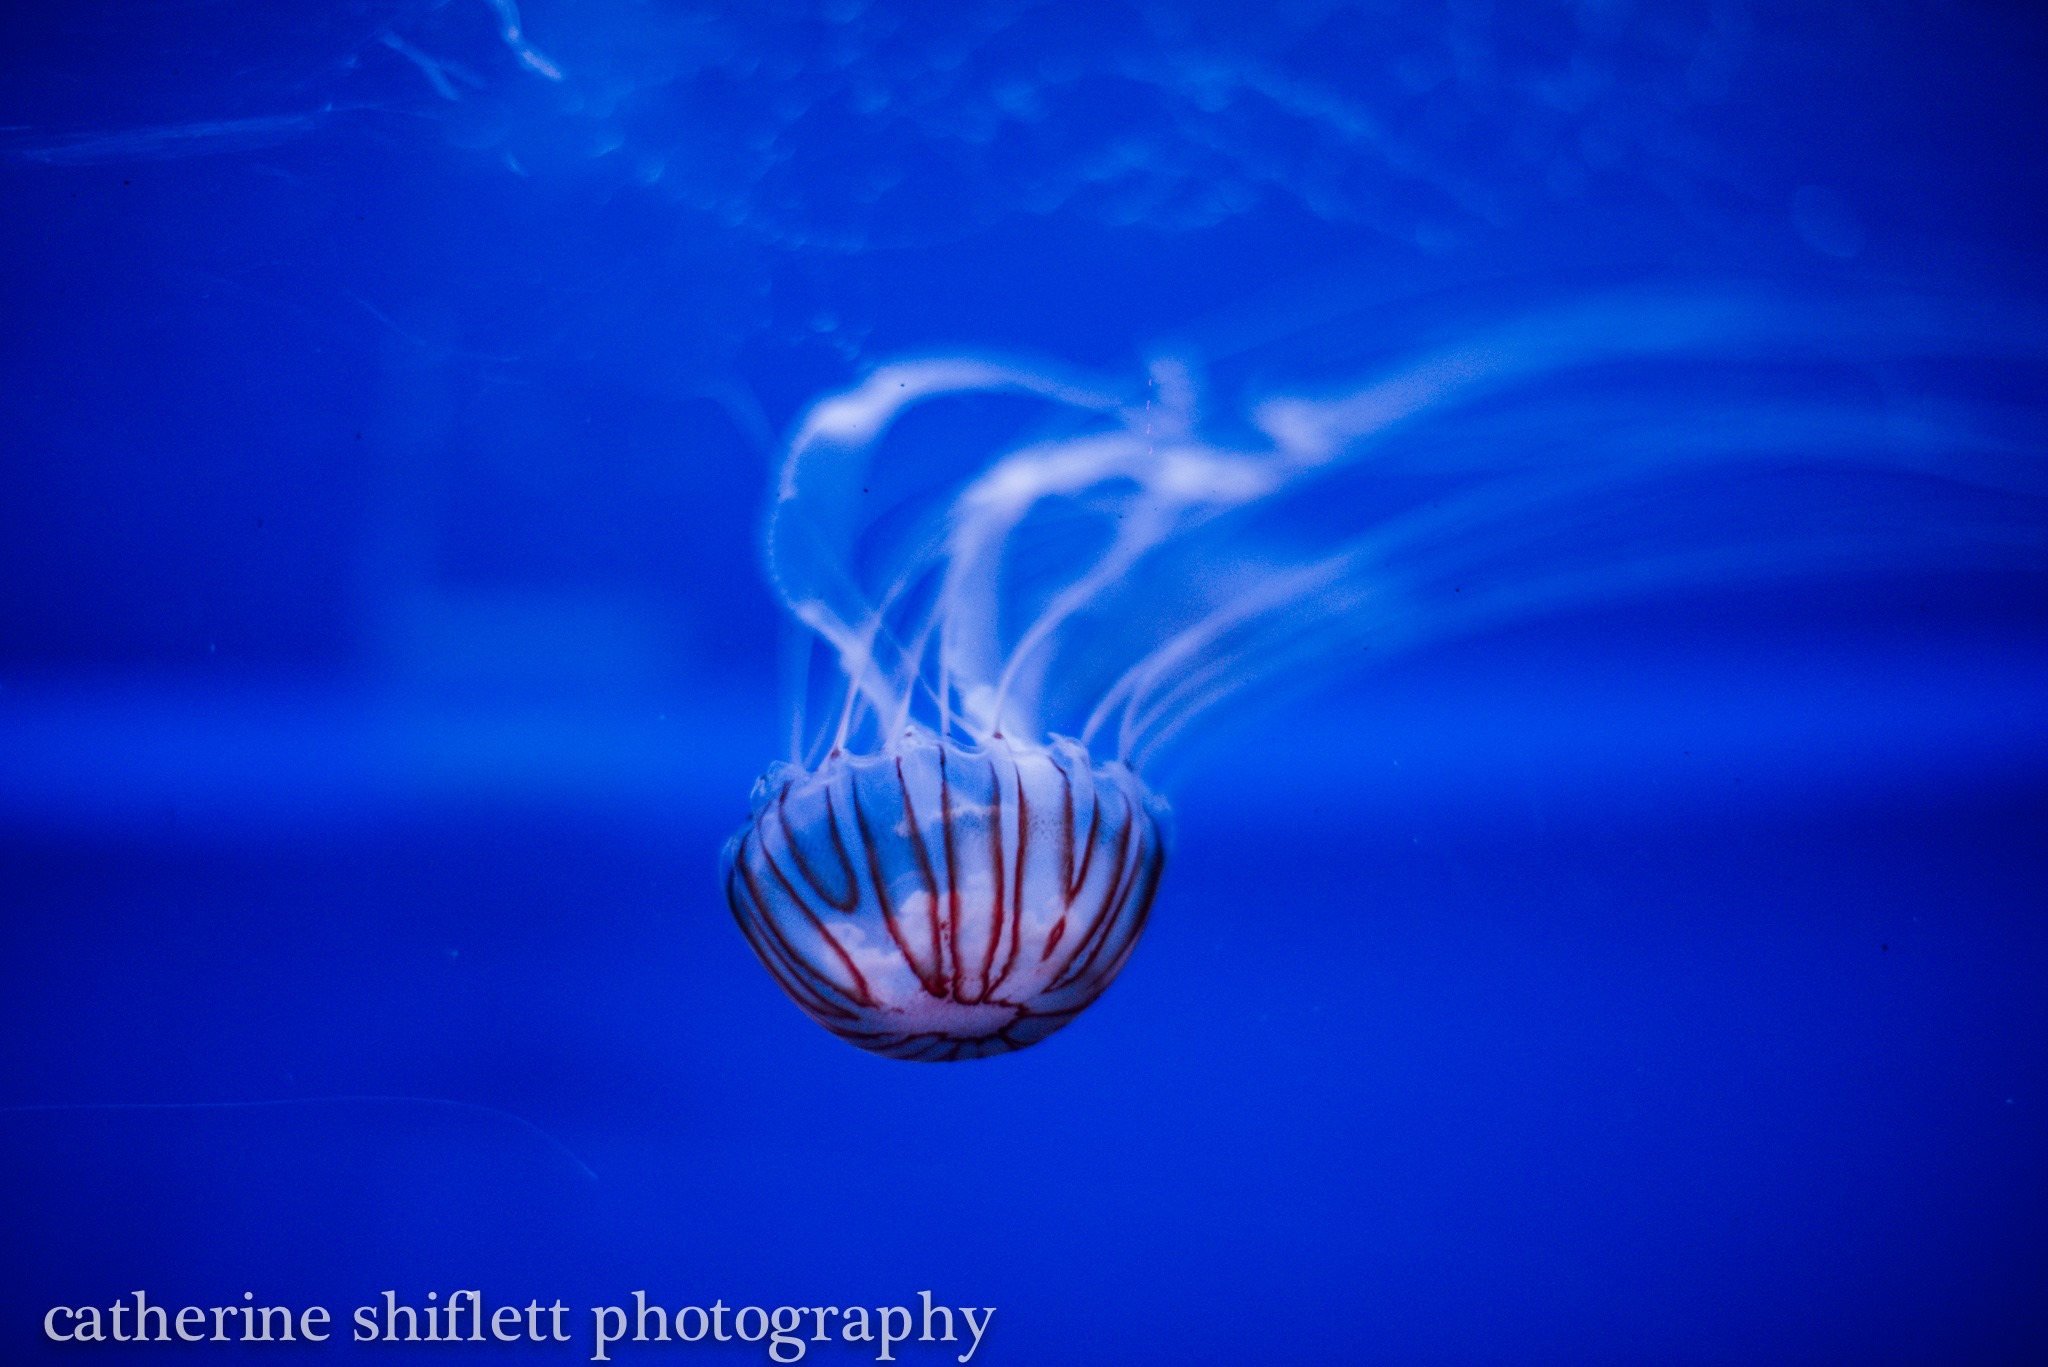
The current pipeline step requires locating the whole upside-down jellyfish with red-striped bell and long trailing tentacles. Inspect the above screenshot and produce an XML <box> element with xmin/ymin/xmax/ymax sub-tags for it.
<box><xmin>723</xmin><ymin>287</ymin><xmax>2048</xmax><ymax>1060</ymax></box>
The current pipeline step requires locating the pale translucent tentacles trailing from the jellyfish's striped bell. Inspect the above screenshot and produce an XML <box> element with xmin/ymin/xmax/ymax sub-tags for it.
<box><xmin>768</xmin><ymin>289</ymin><xmax>2048</xmax><ymax>769</ymax></box>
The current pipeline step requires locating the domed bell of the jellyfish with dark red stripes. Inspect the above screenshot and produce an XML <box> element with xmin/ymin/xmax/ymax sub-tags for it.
<box><xmin>725</xmin><ymin>732</ymin><xmax>1167</xmax><ymax>1062</ymax></box>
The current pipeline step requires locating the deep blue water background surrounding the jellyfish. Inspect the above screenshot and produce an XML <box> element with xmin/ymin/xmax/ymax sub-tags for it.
<box><xmin>0</xmin><ymin>0</ymin><xmax>2048</xmax><ymax>1367</ymax></box>
